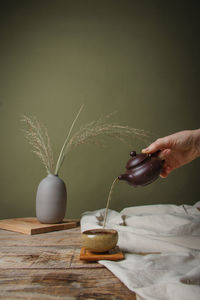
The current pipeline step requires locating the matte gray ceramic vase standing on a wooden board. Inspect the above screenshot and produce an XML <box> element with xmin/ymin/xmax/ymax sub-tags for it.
<box><xmin>36</xmin><ymin>174</ymin><xmax>67</xmax><ymax>224</ymax></box>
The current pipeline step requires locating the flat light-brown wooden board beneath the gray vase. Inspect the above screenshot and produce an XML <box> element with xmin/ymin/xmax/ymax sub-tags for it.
<box><xmin>0</xmin><ymin>218</ymin><xmax>79</xmax><ymax>235</ymax></box>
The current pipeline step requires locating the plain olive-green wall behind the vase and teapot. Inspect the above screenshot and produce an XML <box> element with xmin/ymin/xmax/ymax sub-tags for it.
<box><xmin>0</xmin><ymin>0</ymin><xmax>200</xmax><ymax>218</ymax></box>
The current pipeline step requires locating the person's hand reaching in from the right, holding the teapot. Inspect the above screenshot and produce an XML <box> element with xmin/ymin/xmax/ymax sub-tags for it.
<box><xmin>142</xmin><ymin>129</ymin><xmax>200</xmax><ymax>178</ymax></box>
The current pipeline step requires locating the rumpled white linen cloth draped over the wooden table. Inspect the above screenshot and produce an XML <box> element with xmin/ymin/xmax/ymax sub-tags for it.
<box><xmin>81</xmin><ymin>202</ymin><xmax>200</xmax><ymax>300</ymax></box>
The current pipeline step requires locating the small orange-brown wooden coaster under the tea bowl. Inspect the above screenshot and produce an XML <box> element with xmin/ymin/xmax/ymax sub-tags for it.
<box><xmin>80</xmin><ymin>247</ymin><xmax>124</xmax><ymax>261</ymax></box>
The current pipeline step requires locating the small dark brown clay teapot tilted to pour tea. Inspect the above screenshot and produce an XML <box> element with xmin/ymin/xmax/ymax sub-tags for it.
<box><xmin>118</xmin><ymin>151</ymin><xmax>164</xmax><ymax>186</ymax></box>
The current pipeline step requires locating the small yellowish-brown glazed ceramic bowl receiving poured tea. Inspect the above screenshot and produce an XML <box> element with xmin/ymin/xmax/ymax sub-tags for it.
<box><xmin>81</xmin><ymin>228</ymin><xmax>118</xmax><ymax>252</ymax></box>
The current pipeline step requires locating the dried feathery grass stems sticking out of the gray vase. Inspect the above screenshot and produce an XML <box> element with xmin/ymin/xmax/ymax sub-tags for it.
<box><xmin>22</xmin><ymin>105</ymin><xmax>147</xmax><ymax>175</ymax></box>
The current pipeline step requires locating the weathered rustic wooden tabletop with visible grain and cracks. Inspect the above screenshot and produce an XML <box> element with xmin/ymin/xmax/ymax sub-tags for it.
<box><xmin>0</xmin><ymin>228</ymin><xmax>136</xmax><ymax>300</ymax></box>
